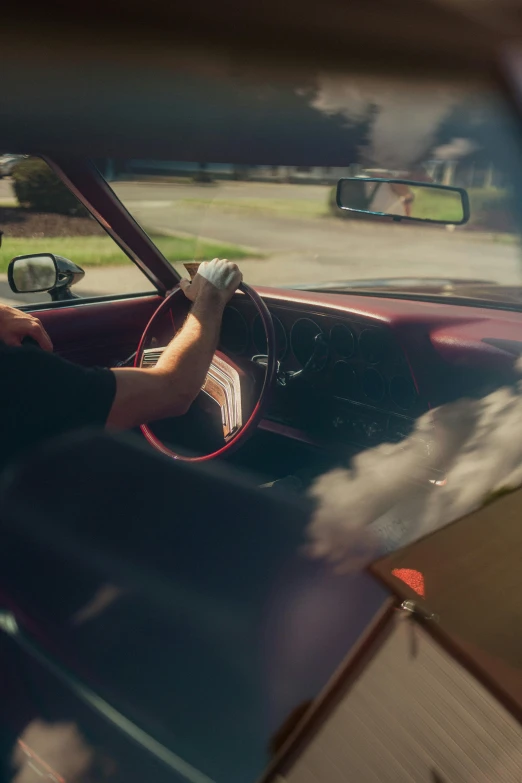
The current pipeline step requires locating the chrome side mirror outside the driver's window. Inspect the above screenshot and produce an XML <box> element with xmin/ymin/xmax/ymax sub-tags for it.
<box><xmin>7</xmin><ymin>253</ymin><xmax>85</xmax><ymax>302</ymax></box>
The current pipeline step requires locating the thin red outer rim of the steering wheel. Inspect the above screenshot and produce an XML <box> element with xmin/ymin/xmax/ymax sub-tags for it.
<box><xmin>134</xmin><ymin>283</ymin><xmax>277</xmax><ymax>462</ymax></box>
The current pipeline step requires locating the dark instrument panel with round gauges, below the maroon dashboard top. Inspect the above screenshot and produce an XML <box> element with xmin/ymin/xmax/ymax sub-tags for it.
<box><xmin>220</xmin><ymin>298</ymin><xmax>428</xmax><ymax>448</ymax></box>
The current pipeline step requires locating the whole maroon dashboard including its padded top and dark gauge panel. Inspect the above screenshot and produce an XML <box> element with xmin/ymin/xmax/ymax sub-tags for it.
<box><xmin>217</xmin><ymin>289</ymin><xmax>522</xmax><ymax>448</ymax></box>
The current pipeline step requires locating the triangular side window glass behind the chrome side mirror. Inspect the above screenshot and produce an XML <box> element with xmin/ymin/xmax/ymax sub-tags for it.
<box><xmin>0</xmin><ymin>154</ymin><xmax>152</xmax><ymax>305</ymax></box>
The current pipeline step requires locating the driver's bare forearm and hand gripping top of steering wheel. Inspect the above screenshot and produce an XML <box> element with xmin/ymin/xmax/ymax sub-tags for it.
<box><xmin>107</xmin><ymin>259</ymin><xmax>242</xmax><ymax>429</ymax></box>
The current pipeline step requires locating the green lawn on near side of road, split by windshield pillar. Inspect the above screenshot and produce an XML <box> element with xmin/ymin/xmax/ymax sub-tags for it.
<box><xmin>0</xmin><ymin>236</ymin><xmax>252</xmax><ymax>272</ymax></box>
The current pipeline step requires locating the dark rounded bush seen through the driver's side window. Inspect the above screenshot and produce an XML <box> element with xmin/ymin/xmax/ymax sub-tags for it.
<box><xmin>13</xmin><ymin>158</ymin><xmax>88</xmax><ymax>216</ymax></box>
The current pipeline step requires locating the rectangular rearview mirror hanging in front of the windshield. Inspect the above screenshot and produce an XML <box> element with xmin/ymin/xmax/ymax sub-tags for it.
<box><xmin>337</xmin><ymin>177</ymin><xmax>469</xmax><ymax>226</ymax></box>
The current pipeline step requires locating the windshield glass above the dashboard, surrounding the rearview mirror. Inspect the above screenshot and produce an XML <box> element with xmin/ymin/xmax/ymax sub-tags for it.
<box><xmin>105</xmin><ymin>76</ymin><xmax>522</xmax><ymax>306</ymax></box>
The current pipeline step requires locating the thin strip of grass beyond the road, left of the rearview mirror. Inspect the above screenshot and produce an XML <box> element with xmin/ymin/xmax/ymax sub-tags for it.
<box><xmin>177</xmin><ymin>198</ymin><xmax>328</xmax><ymax>218</ymax></box>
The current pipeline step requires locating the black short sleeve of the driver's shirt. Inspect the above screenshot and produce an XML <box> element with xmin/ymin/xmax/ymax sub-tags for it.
<box><xmin>0</xmin><ymin>346</ymin><xmax>116</xmax><ymax>467</ymax></box>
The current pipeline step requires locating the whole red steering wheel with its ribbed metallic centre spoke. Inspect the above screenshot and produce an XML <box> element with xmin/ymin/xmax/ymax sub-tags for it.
<box><xmin>134</xmin><ymin>283</ymin><xmax>277</xmax><ymax>462</ymax></box>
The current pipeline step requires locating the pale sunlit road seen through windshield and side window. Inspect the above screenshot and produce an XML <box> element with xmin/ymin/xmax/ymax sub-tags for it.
<box><xmin>0</xmin><ymin>182</ymin><xmax>522</xmax><ymax>301</ymax></box>
